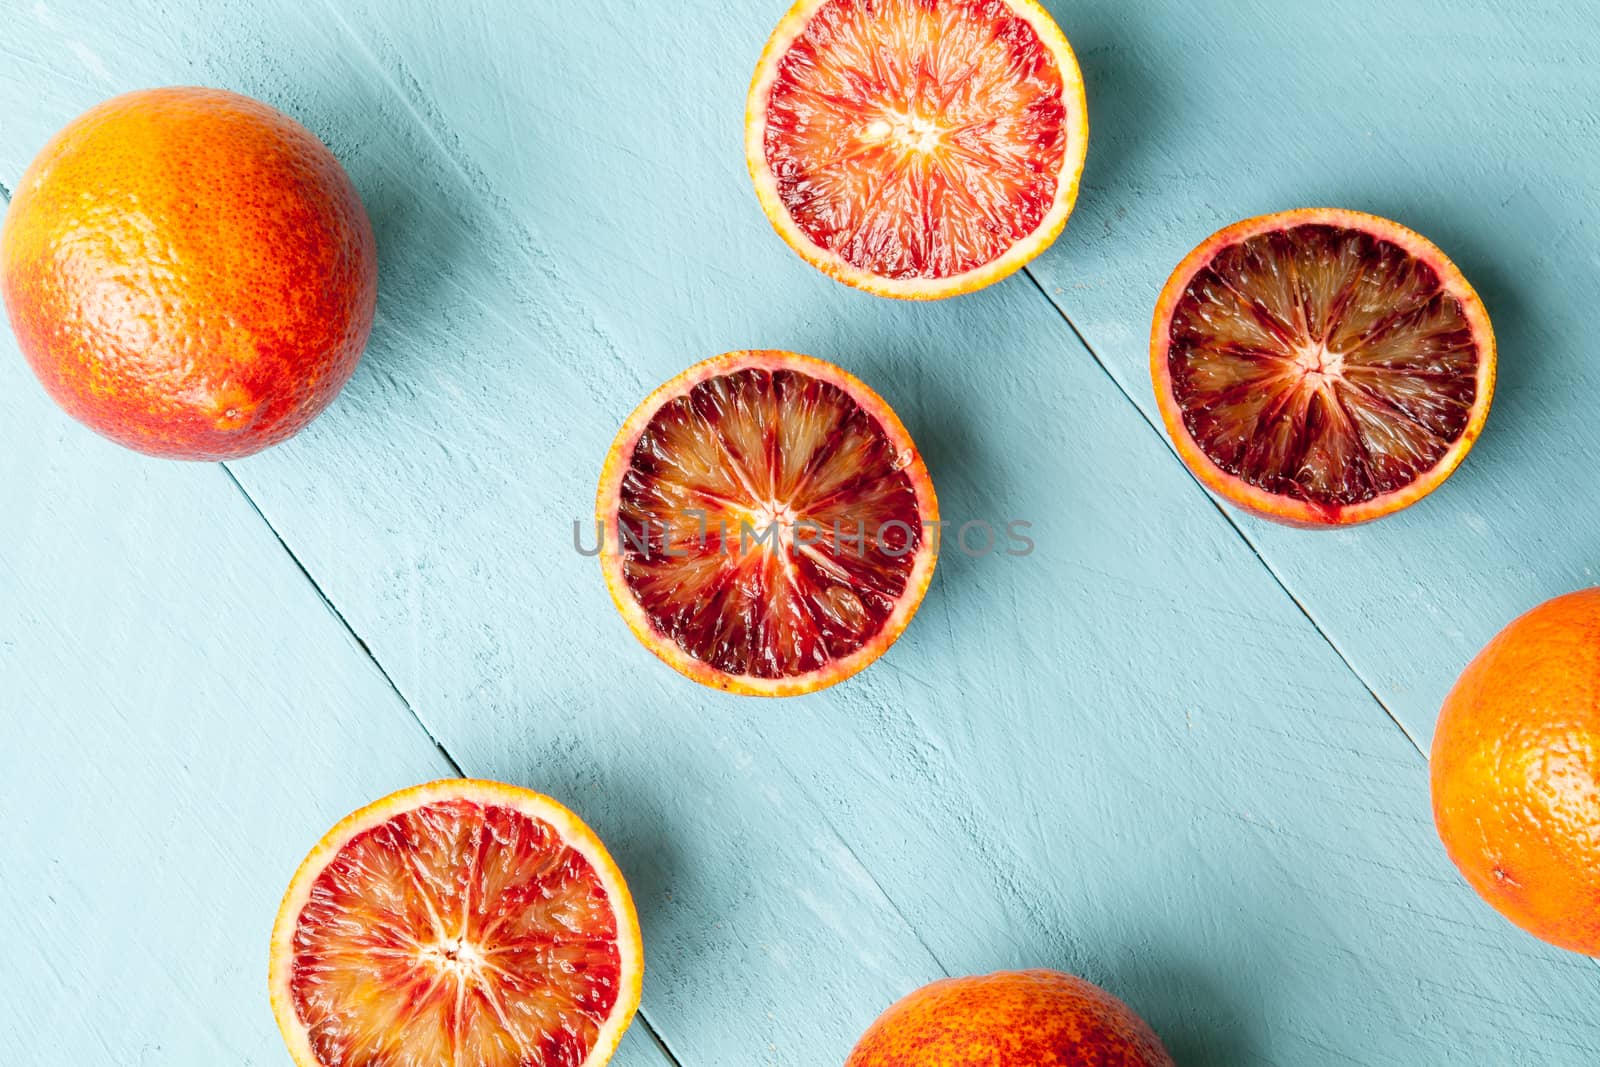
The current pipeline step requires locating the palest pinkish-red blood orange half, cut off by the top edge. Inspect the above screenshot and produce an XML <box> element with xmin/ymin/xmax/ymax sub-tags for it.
<box><xmin>744</xmin><ymin>0</ymin><xmax>1088</xmax><ymax>299</ymax></box>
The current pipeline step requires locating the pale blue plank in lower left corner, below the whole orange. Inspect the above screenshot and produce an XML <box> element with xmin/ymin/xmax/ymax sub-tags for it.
<box><xmin>0</xmin><ymin>333</ymin><xmax>467</xmax><ymax>1064</ymax></box>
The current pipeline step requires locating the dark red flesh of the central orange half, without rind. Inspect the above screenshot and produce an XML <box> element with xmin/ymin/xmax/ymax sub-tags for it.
<box><xmin>619</xmin><ymin>368</ymin><xmax>925</xmax><ymax>678</ymax></box>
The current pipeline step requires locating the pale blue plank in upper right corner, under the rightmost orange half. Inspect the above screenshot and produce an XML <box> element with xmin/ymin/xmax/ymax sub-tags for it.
<box><xmin>1034</xmin><ymin>0</ymin><xmax>1600</xmax><ymax>750</ymax></box>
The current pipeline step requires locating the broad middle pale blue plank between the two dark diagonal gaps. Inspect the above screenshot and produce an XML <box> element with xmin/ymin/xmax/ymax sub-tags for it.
<box><xmin>0</xmin><ymin>0</ymin><xmax>1600</xmax><ymax>1067</ymax></box>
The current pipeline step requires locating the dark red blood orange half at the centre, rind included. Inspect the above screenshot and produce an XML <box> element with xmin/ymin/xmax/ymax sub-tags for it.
<box><xmin>595</xmin><ymin>352</ymin><xmax>939</xmax><ymax>696</ymax></box>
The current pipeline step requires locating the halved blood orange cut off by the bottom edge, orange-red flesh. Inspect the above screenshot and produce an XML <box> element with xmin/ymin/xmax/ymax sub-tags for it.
<box><xmin>270</xmin><ymin>779</ymin><xmax>645</xmax><ymax>1067</ymax></box>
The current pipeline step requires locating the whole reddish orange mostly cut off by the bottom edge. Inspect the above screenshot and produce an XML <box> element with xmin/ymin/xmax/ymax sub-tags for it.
<box><xmin>845</xmin><ymin>971</ymin><xmax>1173</xmax><ymax>1067</ymax></box>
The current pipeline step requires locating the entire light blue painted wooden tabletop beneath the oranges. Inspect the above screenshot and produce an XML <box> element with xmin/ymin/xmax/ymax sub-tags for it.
<box><xmin>0</xmin><ymin>0</ymin><xmax>1600</xmax><ymax>1067</ymax></box>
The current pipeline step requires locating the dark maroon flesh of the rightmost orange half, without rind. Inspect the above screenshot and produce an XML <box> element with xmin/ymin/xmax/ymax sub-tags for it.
<box><xmin>1168</xmin><ymin>224</ymin><xmax>1480</xmax><ymax>509</ymax></box>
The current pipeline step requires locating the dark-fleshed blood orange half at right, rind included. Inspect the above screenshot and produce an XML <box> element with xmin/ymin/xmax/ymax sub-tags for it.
<box><xmin>1150</xmin><ymin>208</ymin><xmax>1494</xmax><ymax>526</ymax></box>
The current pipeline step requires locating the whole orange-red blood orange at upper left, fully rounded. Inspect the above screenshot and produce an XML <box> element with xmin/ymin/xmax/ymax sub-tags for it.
<box><xmin>0</xmin><ymin>88</ymin><xmax>378</xmax><ymax>459</ymax></box>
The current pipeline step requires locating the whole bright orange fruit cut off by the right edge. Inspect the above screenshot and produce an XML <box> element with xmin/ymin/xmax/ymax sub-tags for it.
<box><xmin>1432</xmin><ymin>589</ymin><xmax>1600</xmax><ymax>955</ymax></box>
